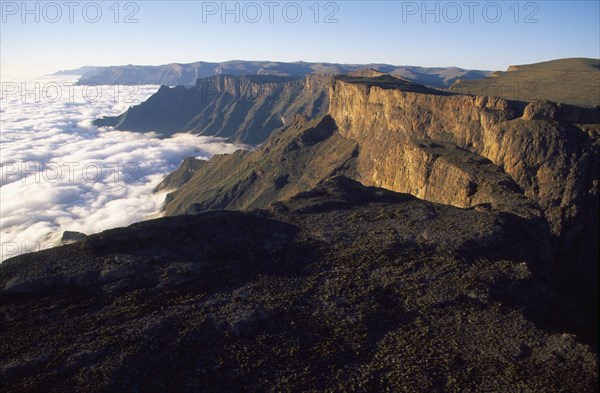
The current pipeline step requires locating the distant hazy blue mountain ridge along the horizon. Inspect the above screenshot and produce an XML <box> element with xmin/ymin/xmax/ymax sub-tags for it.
<box><xmin>60</xmin><ymin>60</ymin><xmax>493</xmax><ymax>87</ymax></box>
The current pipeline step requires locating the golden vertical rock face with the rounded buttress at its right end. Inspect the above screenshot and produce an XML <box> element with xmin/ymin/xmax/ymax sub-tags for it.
<box><xmin>330</xmin><ymin>79</ymin><xmax>600</xmax><ymax>306</ymax></box>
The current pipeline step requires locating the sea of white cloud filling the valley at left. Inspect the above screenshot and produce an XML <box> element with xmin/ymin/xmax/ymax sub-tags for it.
<box><xmin>0</xmin><ymin>76</ymin><xmax>242</xmax><ymax>260</ymax></box>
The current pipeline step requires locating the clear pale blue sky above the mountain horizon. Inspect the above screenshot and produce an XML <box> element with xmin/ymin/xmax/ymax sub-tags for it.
<box><xmin>0</xmin><ymin>0</ymin><xmax>600</xmax><ymax>75</ymax></box>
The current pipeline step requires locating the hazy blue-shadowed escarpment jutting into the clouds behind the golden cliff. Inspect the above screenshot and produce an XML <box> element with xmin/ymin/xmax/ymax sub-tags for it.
<box><xmin>94</xmin><ymin>74</ymin><xmax>331</xmax><ymax>144</ymax></box>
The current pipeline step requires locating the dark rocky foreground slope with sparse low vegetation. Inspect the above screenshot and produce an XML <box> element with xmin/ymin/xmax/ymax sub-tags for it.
<box><xmin>0</xmin><ymin>177</ymin><xmax>597</xmax><ymax>392</ymax></box>
